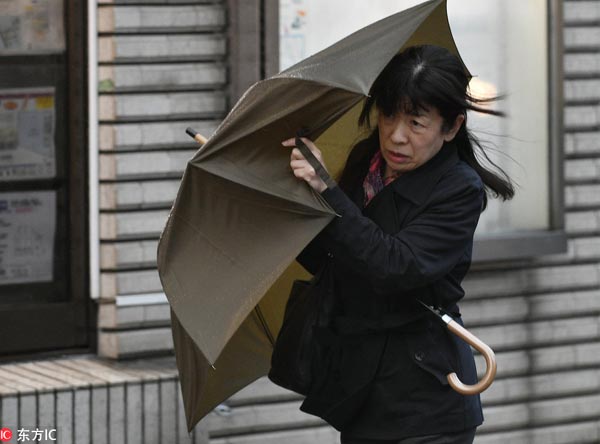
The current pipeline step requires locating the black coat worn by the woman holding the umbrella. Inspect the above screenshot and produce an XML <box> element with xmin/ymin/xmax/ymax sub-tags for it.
<box><xmin>297</xmin><ymin>143</ymin><xmax>484</xmax><ymax>439</ymax></box>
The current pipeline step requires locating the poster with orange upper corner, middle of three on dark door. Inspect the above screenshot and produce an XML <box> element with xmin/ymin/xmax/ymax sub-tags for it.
<box><xmin>0</xmin><ymin>87</ymin><xmax>56</xmax><ymax>181</ymax></box>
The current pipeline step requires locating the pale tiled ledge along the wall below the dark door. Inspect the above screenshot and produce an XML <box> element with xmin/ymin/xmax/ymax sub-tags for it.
<box><xmin>0</xmin><ymin>356</ymin><xmax>208</xmax><ymax>444</ymax></box>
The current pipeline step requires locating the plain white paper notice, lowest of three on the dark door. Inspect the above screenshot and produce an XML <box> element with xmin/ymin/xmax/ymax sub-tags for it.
<box><xmin>0</xmin><ymin>191</ymin><xmax>56</xmax><ymax>285</ymax></box>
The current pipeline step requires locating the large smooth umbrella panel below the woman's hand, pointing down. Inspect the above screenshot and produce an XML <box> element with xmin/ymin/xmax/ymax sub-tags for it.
<box><xmin>159</xmin><ymin>165</ymin><xmax>332</xmax><ymax>363</ymax></box>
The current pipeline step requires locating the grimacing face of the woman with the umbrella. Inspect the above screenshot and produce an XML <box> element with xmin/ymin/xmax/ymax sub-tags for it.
<box><xmin>377</xmin><ymin>107</ymin><xmax>464</xmax><ymax>177</ymax></box>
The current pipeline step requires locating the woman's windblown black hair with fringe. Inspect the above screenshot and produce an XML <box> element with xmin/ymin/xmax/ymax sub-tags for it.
<box><xmin>340</xmin><ymin>45</ymin><xmax>515</xmax><ymax>209</ymax></box>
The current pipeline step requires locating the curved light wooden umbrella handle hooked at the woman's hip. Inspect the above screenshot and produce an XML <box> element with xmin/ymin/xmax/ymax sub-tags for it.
<box><xmin>447</xmin><ymin>320</ymin><xmax>497</xmax><ymax>395</ymax></box>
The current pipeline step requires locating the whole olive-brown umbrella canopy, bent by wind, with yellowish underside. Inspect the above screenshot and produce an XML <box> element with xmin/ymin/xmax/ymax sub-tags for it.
<box><xmin>158</xmin><ymin>0</ymin><xmax>466</xmax><ymax>430</ymax></box>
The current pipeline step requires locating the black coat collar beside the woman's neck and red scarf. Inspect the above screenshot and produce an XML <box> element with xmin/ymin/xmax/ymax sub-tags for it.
<box><xmin>389</xmin><ymin>142</ymin><xmax>460</xmax><ymax>205</ymax></box>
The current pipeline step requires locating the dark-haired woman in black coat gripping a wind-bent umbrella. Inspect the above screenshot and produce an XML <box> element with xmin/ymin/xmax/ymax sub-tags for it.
<box><xmin>283</xmin><ymin>46</ymin><xmax>514</xmax><ymax>444</ymax></box>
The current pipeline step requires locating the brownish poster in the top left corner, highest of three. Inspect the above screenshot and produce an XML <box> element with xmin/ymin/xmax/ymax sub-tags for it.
<box><xmin>0</xmin><ymin>0</ymin><xmax>65</xmax><ymax>55</ymax></box>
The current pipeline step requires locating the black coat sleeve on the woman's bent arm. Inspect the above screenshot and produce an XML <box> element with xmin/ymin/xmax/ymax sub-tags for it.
<box><xmin>322</xmin><ymin>170</ymin><xmax>484</xmax><ymax>294</ymax></box>
